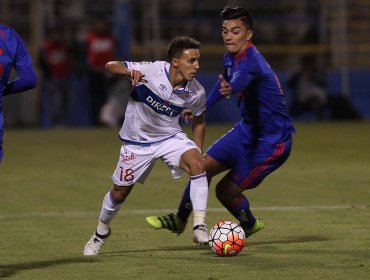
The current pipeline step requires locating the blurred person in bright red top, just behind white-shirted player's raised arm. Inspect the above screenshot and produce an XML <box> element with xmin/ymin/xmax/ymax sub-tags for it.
<box><xmin>86</xmin><ymin>17</ymin><xmax>117</xmax><ymax>125</ymax></box>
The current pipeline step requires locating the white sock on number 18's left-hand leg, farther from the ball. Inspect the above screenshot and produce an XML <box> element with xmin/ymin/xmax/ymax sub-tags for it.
<box><xmin>96</xmin><ymin>191</ymin><xmax>122</xmax><ymax>236</ymax></box>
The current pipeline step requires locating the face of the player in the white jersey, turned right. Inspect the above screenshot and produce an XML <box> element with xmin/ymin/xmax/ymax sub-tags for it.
<box><xmin>177</xmin><ymin>49</ymin><xmax>200</xmax><ymax>81</ymax></box>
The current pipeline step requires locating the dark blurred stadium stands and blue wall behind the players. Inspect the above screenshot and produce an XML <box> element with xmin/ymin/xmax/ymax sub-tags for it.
<box><xmin>0</xmin><ymin>0</ymin><xmax>370</xmax><ymax>126</ymax></box>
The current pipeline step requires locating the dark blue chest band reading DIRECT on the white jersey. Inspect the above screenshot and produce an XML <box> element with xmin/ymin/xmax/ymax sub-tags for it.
<box><xmin>131</xmin><ymin>85</ymin><xmax>184</xmax><ymax>117</ymax></box>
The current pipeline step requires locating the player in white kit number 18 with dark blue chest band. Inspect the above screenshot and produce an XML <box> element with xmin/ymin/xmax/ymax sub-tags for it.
<box><xmin>83</xmin><ymin>36</ymin><xmax>208</xmax><ymax>256</ymax></box>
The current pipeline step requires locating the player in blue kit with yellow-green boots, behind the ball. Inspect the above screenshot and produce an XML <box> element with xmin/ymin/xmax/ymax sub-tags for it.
<box><xmin>147</xmin><ymin>7</ymin><xmax>295</xmax><ymax>237</ymax></box>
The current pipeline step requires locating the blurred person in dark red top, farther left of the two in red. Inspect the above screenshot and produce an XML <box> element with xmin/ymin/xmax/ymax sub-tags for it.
<box><xmin>39</xmin><ymin>27</ymin><xmax>72</xmax><ymax>127</ymax></box>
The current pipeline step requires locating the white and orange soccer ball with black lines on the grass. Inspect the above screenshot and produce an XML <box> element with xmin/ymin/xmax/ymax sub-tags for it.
<box><xmin>208</xmin><ymin>221</ymin><xmax>246</xmax><ymax>257</ymax></box>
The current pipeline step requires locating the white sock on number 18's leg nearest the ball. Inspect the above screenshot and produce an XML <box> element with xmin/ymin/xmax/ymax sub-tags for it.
<box><xmin>190</xmin><ymin>172</ymin><xmax>208</xmax><ymax>226</ymax></box>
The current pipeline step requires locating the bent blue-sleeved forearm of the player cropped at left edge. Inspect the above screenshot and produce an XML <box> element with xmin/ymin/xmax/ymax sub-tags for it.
<box><xmin>4</xmin><ymin>66</ymin><xmax>37</xmax><ymax>96</ymax></box>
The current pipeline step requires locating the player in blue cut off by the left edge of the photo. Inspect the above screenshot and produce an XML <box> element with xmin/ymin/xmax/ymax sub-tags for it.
<box><xmin>0</xmin><ymin>24</ymin><xmax>37</xmax><ymax>162</ymax></box>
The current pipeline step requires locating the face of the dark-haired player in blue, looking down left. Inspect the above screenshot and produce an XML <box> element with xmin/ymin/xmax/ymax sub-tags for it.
<box><xmin>222</xmin><ymin>19</ymin><xmax>253</xmax><ymax>55</ymax></box>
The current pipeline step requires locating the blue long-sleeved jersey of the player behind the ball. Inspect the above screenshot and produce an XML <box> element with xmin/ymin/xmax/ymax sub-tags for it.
<box><xmin>211</xmin><ymin>44</ymin><xmax>295</xmax><ymax>144</ymax></box>
